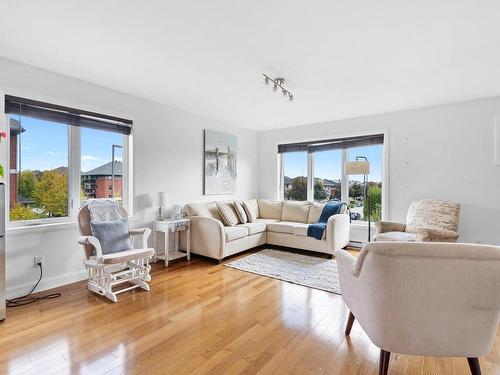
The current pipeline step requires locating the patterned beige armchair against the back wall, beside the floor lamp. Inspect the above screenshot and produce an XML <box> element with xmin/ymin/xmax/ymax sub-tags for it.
<box><xmin>372</xmin><ymin>199</ymin><xmax>460</xmax><ymax>242</ymax></box>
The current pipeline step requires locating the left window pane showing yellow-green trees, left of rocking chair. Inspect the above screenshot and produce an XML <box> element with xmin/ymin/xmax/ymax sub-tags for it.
<box><xmin>9</xmin><ymin>115</ymin><xmax>69</xmax><ymax>221</ymax></box>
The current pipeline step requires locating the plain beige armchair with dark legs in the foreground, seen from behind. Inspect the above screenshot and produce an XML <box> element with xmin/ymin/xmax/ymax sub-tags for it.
<box><xmin>335</xmin><ymin>242</ymin><xmax>500</xmax><ymax>375</ymax></box>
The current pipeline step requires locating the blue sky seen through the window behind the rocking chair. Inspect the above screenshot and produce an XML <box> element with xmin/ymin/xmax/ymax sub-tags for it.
<box><xmin>14</xmin><ymin>116</ymin><xmax>123</xmax><ymax>172</ymax></box>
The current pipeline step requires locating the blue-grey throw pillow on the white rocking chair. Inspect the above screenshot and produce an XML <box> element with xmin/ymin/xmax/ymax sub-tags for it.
<box><xmin>90</xmin><ymin>218</ymin><xmax>132</xmax><ymax>254</ymax></box>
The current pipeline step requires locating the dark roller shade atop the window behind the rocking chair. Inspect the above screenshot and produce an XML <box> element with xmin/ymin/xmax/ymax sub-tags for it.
<box><xmin>5</xmin><ymin>95</ymin><xmax>132</xmax><ymax>135</ymax></box>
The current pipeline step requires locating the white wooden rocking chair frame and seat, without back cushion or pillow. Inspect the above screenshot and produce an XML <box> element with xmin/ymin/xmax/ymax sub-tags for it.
<box><xmin>78</xmin><ymin>206</ymin><xmax>154</xmax><ymax>302</ymax></box>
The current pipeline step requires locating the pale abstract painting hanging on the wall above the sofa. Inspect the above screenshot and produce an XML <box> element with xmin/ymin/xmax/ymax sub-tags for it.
<box><xmin>203</xmin><ymin>130</ymin><xmax>237</xmax><ymax>195</ymax></box>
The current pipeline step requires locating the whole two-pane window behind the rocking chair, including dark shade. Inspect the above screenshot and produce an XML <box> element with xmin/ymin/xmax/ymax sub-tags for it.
<box><xmin>5</xmin><ymin>96</ymin><xmax>132</xmax><ymax>223</ymax></box>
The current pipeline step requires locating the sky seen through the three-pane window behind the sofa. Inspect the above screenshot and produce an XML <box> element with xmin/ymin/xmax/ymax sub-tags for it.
<box><xmin>284</xmin><ymin>145</ymin><xmax>382</xmax><ymax>182</ymax></box>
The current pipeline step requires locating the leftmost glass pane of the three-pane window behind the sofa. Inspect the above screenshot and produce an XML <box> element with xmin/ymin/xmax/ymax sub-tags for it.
<box><xmin>282</xmin><ymin>152</ymin><xmax>307</xmax><ymax>201</ymax></box>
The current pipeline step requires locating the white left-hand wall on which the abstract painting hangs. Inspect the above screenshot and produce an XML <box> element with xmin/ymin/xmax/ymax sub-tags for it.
<box><xmin>0</xmin><ymin>59</ymin><xmax>258</xmax><ymax>297</ymax></box>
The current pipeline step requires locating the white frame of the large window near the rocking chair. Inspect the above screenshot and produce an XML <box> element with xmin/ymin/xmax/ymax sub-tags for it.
<box><xmin>0</xmin><ymin>92</ymin><xmax>135</xmax><ymax>230</ymax></box>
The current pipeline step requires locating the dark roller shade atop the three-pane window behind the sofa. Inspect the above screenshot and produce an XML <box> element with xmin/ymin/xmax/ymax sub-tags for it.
<box><xmin>278</xmin><ymin>134</ymin><xmax>384</xmax><ymax>153</ymax></box>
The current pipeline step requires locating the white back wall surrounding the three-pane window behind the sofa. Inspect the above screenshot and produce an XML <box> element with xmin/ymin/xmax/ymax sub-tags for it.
<box><xmin>258</xmin><ymin>98</ymin><xmax>500</xmax><ymax>245</ymax></box>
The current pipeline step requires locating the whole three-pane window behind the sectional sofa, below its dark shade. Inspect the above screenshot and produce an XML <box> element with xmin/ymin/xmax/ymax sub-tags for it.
<box><xmin>278</xmin><ymin>134</ymin><xmax>384</xmax><ymax>224</ymax></box>
